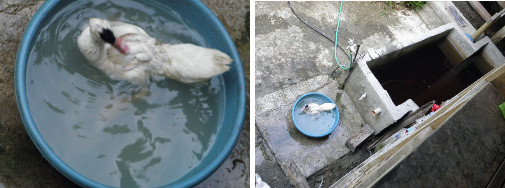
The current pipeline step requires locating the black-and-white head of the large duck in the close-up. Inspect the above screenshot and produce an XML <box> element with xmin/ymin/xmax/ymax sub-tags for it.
<box><xmin>89</xmin><ymin>18</ymin><xmax>129</xmax><ymax>54</ymax></box>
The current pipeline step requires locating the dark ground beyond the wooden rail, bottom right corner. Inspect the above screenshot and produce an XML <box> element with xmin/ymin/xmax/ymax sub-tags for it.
<box><xmin>374</xmin><ymin>83</ymin><xmax>505</xmax><ymax>187</ymax></box>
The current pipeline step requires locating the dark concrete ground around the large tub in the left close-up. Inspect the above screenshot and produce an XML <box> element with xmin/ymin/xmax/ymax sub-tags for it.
<box><xmin>0</xmin><ymin>0</ymin><xmax>250</xmax><ymax>187</ymax></box>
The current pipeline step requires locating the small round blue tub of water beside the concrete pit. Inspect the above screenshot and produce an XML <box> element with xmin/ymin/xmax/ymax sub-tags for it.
<box><xmin>291</xmin><ymin>93</ymin><xmax>339</xmax><ymax>138</ymax></box>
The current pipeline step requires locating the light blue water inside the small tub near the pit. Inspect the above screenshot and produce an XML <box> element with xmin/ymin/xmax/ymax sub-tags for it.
<box><xmin>294</xmin><ymin>97</ymin><xmax>337</xmax><ymax>136</ymax></box>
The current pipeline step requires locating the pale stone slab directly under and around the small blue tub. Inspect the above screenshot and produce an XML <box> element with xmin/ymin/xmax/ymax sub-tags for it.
<box><xmin>256</xmin><ymin>80</ymin><xmax>370</xmax><ymax>177</ymax></box>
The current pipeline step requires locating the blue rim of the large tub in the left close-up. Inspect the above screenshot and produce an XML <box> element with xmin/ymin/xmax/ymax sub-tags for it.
<box><xmin>14</xmin><ymin>0</ymin><xmax>246</xmax><ymax>187</ymax></box>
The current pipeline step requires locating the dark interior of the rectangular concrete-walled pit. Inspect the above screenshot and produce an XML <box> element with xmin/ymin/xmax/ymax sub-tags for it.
<box><xmin>369</xmin><ymin>42</ymin><xmax>483</xmax><ymax>106</ymax></box>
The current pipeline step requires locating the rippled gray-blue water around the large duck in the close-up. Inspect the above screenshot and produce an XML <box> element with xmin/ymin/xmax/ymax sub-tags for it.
<box><xmin>26</xmin><ymin>0</ymin><xmax>224</xmax><ymax>187</ymax></box>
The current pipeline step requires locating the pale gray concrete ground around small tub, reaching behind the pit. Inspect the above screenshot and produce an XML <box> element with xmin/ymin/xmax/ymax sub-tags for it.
<box><xmin>254</xmin><ymin>2</ymin><xmax>488</xmax><ymax>187</ymax></box>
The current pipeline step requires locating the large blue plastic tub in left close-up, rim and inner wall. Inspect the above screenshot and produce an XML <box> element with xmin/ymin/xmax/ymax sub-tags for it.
<box><xmin>15</xmin><ymin>0</ymin><xmax>246</xmax><ymax>187</ymax></box>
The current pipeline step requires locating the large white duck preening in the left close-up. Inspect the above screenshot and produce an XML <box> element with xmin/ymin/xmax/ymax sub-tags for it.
<box><xmin>77</xmin><ymin>18</ymin><xmax>232</xmax><ymax>83</ymax></box>
